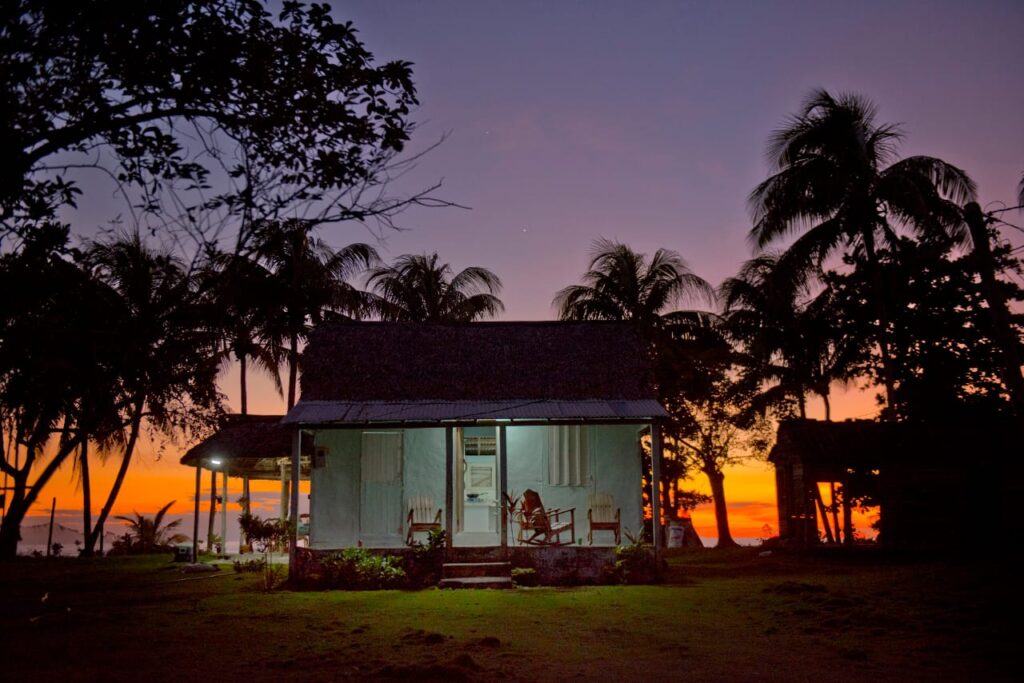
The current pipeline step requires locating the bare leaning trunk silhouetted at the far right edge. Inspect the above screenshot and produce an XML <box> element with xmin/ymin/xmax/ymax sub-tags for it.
<box><xmin>964</xmin><ymin>202</ymin><xmax>1024</xmax><ymax>425</ymax></box>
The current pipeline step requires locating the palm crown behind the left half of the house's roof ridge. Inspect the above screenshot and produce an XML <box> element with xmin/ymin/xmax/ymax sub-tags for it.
<box><xmin>367</xmin><ymin>254</ymin><xmax>505</xmax><ymax>323</ymax></box>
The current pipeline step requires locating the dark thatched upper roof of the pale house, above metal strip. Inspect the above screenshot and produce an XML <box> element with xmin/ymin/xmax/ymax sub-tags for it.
<box><xmin>301</xmin><ymin>322</ymin><xmax>656</xmax><ymax>401</ymax></box>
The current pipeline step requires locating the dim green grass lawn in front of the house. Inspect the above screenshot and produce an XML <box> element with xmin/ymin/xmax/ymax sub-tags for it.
<box><xmin>0</xmin><ymin>549</ymin><xmax>1007</xmax><ymax>682</ymax></box>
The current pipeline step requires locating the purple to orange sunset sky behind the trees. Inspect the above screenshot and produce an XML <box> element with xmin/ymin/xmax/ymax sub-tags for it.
<box><xmin>16</xmin><ymin>0</ymin><xmax>1024</xmax><ymax>539</ymax></box>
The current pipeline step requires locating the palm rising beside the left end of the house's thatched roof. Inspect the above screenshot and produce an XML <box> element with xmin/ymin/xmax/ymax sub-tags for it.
<box><xmin>255</xmin><ymin>220</ymin><xmax>380</xmax><ymax>410</ymax></box>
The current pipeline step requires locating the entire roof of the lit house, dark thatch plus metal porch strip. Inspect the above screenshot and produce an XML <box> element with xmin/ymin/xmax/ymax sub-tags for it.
<box><xmin>285</xmin><ymin>322</ymin><xmax>665</xmax><ymax>424</ymax></box>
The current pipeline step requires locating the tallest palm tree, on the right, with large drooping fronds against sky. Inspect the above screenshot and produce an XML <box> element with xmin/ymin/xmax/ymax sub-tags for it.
<box><xmin>750</xmin><ymin>90</ymin><xmax>975</xmax><ymax>413</ymax></box>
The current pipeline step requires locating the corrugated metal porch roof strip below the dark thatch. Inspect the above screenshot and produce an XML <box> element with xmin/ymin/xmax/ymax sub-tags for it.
<box><xmin>282</xmin><ymin>398</ymin><xmax>668</xmax><ymax>424</ymax></box>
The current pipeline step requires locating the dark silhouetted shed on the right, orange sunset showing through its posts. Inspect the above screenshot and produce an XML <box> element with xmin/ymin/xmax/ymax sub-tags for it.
<box><xmin>768</xmin><ymin>420</ymin><xmax>1024</xmax><ymax>548</ymax></box>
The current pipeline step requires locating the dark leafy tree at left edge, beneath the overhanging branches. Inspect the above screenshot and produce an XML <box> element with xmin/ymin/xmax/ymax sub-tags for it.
<box><xmin>0</xmin><ymin>224</ymin><xmax>122</xmax><ymax>557</ymax></box>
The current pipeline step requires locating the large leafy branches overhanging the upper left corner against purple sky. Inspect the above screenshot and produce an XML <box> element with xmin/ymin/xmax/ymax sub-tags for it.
<box><xmin>0</xmin><ymin>0</ymin><xmax>433</xmax><ymax>242</ymax></box>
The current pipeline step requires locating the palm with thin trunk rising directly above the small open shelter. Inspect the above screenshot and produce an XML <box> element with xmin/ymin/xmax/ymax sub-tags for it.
<box><xmin>202</xmin><ymin>253</ymin><xmax>283</xmax><ymax>415</ymax></box>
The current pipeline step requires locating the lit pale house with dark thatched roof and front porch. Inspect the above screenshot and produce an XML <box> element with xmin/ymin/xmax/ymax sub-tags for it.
<box><xmin>183</xmin><ymin>322</ymin><xmax>667</xmax><ymax>577</ymax></box>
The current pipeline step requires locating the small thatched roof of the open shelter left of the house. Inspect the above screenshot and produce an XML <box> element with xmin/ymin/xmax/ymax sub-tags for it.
<box><xmin>181</xmin><ymin>415</ymin><xmax>309</xmax><ymax>479</ymax></box>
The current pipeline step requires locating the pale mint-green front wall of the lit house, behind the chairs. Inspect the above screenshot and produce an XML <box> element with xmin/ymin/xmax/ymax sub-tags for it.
<box><xmin>309</xmin><ymin>425</ymin><xmax>642</xmax><ymax>549</ymax></box>
